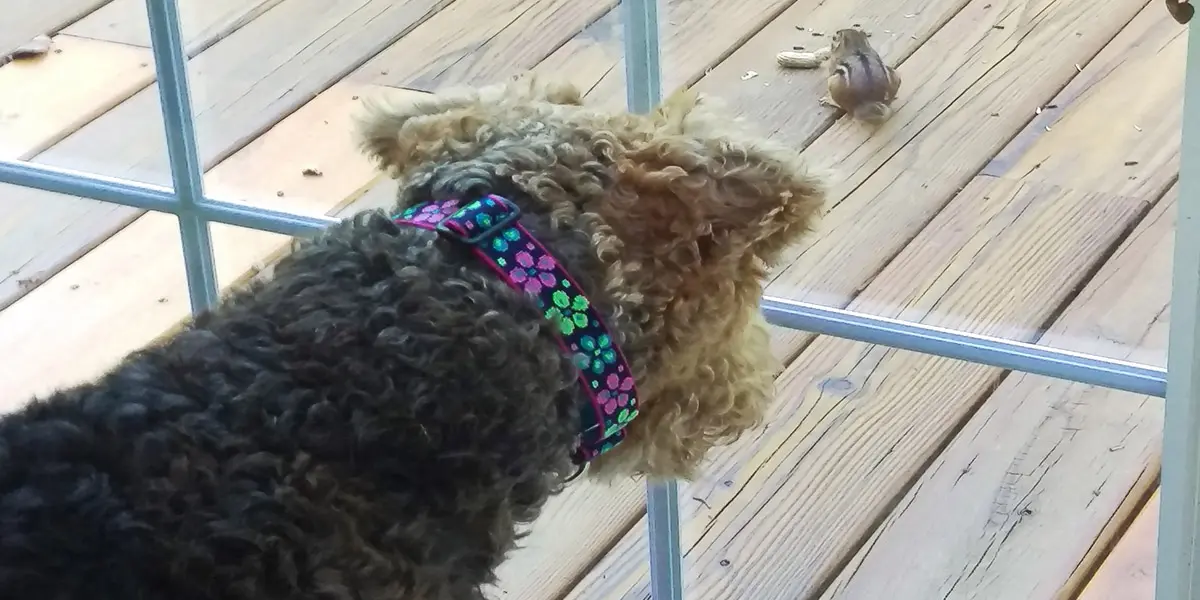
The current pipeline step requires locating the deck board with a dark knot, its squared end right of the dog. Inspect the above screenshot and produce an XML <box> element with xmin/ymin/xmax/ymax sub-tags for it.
<box><xmin>672</xmin><ymin>179</ymin><xmax>1156</xmax><ymax>598</ymax></box>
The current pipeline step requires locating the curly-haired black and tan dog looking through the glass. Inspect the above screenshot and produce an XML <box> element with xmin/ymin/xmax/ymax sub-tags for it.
<box><xmin>0</xmin><ymin>77</ymin><xmax>823</xmax><ymax>600</ymax></box>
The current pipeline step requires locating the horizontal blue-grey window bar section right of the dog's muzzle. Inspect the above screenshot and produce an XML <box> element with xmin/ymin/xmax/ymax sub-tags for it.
<box><xmin>762</xmin><ymin>296</ymin><xmax>1166</xmax><ymax>397</ymax></box>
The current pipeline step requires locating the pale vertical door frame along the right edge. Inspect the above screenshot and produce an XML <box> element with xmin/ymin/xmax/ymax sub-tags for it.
<box><xmin>1154</xmin><ymin>16</ymin><xmax>1200</xmax><ymax>600</ymax></box>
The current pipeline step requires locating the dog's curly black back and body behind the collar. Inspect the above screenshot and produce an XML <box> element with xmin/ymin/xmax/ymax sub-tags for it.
<box><xmin>0</xmin><ymin>215</ymin><xmax>578</xmax><ymax>600</ymax></box>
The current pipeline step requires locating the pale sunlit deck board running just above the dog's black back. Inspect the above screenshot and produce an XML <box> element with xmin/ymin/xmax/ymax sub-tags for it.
<box><xmin>0</xmin><ymin>85</ymin><xmax>400</xmax><ymax>412</ymax></box>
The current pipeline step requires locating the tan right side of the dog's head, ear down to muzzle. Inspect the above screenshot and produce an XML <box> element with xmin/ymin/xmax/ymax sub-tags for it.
<box><xmin>580</xmin><ymin>91</ymin><xmax>826</xmax><ymax>478</ymax></box>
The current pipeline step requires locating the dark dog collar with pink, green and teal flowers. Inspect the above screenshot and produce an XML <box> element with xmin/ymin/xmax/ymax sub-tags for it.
<box><xmin>394</xmin><ymin>194</ymin><xmax>637</xmax><ymax>468</ymax></box>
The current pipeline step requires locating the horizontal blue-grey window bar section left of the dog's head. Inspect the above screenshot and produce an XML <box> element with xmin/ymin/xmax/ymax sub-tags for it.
<box><xmin>0</xmin><ymin>160</ymin><xmax>338</xmax><ymax>236</ymax></box>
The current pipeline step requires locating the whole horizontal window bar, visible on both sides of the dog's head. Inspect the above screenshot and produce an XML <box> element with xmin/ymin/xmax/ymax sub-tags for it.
<box><xmin>0</xmin><ymin>161</ymin><xmax>1166</xmax><ymax>397</ymax></box>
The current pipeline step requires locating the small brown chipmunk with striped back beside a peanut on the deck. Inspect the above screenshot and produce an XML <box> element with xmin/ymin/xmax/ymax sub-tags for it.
<box><xmin>821</xmin><ymin>29</ymin><xmax>900</xmax><ymax>125</ymax></box>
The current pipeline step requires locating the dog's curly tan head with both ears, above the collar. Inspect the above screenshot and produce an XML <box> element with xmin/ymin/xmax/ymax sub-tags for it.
<box><xmin>362</xmin><ymin>76</ymin><xmax>824</xmax><ymax>478</ymax></box>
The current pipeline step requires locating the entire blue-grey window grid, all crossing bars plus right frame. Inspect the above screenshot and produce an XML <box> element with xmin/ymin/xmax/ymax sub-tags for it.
<box><xmin>0</xmin><ymin>0</ymin><xmax>1200</xmax><ymax>600</ymax></box>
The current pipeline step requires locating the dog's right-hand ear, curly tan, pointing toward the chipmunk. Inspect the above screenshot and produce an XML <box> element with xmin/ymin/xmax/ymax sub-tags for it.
<box><xmin>614</xmin><ymin>96</ymin><xmax>826</xmax><ymax>272</ymax></box>
